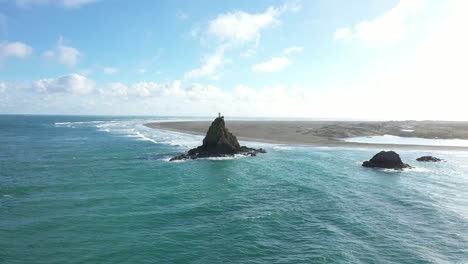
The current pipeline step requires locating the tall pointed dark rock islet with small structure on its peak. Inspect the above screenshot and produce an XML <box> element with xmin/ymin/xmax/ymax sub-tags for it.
<box><xmin>170</xmin><ymin>116</ymin><xmax>266</xmax><ymax>161</ymax></box>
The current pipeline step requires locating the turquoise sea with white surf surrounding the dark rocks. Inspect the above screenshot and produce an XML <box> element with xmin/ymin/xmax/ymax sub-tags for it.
<box><xmin>0</xmin><ymin>116</ymin><xmax>468</xmax><ymax>263</ymax></box>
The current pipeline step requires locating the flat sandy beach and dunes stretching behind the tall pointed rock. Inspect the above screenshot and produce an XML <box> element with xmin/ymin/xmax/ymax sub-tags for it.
<box><xmin>145</xmin><ymin>119</ymin><xmax>468</xmax><ymax>151</ymax></box>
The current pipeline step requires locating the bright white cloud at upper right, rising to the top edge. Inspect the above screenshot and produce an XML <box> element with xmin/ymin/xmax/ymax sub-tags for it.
<box><xmin>334</xmin><ymin>0</ymin><xmax>424</xmax><ymax>43</ymax></box>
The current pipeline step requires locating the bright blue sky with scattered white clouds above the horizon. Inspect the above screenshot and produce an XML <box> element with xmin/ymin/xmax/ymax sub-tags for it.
<box><xmin>0</xmin><ymin>0</ymin><xmax>468</xmax><ymax>120</ymax></box>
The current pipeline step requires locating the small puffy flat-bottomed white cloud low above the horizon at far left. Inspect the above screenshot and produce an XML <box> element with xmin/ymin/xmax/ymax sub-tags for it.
<box><xmin>32</xmin><ymin>73</ymin><xmax>95</xmax><ymax>94</ymax></box>
